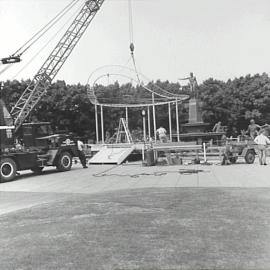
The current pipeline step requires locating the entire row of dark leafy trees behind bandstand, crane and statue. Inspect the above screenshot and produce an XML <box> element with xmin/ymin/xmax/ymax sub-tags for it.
<box><xmin>1</xmin><ymin>73</ymin><xmax>270</xmax><ymax>139</ymax></box>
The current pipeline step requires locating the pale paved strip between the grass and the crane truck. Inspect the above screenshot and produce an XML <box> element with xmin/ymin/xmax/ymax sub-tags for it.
<box><xmin>0</xmin><ymin>158</ymin><xmax>270</xmax><ymax>214</ymax></box>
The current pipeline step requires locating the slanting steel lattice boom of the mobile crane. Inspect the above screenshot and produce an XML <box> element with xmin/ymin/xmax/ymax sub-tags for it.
<box><xmin>11</xmin><ymin>0</ymin><xmax>104</xmax><ymax>130</ymax></box>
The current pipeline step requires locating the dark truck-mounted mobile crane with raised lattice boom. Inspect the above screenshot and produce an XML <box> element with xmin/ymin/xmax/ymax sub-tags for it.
<box><xmin>0</xmin><ymin>0</ymin><xmax>104</xmax><ymax>182</ymax></box>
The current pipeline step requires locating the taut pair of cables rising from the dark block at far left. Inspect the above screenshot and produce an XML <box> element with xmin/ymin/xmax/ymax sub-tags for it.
<box><xmin>11</xmin><ymin>0</ymin><xmax>80</xmax><ymax>56</ymax></box>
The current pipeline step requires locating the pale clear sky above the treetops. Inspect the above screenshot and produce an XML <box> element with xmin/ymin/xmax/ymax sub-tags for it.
<box><xmin>0</xmin><ymin>0</ymin><xmax>270</xmax><ymax>84</ymax></box>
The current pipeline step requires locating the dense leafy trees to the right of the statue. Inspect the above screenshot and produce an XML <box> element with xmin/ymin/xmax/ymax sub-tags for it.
<box><xmin>200</xmin><ymin>73</ymin><xmax>270</xmax><ymax>130</ymax></box>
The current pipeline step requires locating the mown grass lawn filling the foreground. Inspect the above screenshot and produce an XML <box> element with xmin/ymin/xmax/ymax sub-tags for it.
<box><xmin>0</xmin><ymin>188</ymin><xmax>270</xmax><ymax>270</ymax></box>
